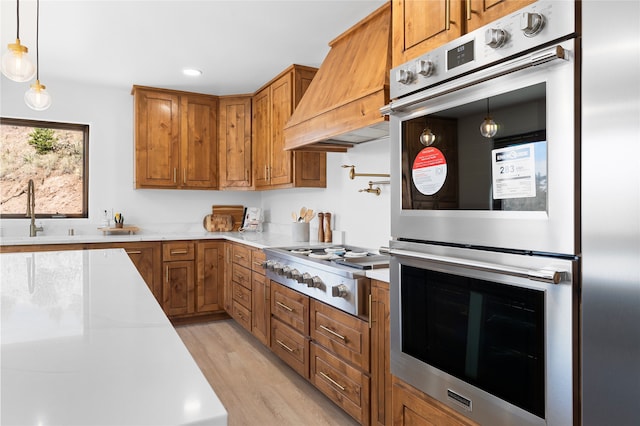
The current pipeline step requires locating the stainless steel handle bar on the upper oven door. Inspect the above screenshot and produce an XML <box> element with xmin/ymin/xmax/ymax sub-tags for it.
<box><xmin>380</xmin><ymin>45</ymin><xmax>569</xmax><ymax>115</ymax></box>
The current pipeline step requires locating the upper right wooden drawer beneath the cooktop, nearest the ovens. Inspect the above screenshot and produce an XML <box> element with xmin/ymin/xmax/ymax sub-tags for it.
<box><xmin>310</xmin><ymin>300</ymin><xmax>370</xmax><ymax>372</ymax></box>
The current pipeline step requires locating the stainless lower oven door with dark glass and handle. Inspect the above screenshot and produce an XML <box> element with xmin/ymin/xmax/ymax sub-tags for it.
<box><xmin>390</xmin><ymin>241</ymin><xmax>579</xmax><ymax>425</ymax></box>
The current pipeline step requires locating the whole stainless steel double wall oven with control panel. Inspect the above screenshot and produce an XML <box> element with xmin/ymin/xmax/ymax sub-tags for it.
<box><xmin>383</xmin><ymin>0</ymin><xmax>580</xmax><ymax>425</ymax></box>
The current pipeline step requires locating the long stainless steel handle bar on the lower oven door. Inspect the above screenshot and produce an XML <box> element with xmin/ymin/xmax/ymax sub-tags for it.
<box><xmin>389</xmin><ymin>248</ymin><xmax>567</xmax><ymax>284</ymax></box>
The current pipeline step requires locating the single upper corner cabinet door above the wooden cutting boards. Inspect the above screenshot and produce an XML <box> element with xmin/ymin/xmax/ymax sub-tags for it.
<box><xmin>218</xmin><ymin>96</ymin><xmax>251</xmax><ymax>189</ymax></box>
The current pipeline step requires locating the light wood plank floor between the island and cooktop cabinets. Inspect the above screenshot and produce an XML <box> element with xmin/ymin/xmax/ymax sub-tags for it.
<box><xmin>176</xmin><ymin>320</ymin><xmax>358</xmax><ymax>426</ymax></box>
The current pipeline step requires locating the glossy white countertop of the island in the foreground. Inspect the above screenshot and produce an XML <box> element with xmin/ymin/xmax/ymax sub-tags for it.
<box><xmin>0</xmin><ymin>249</ymin><xmax>227</xmax><ymax>425</ymax></box>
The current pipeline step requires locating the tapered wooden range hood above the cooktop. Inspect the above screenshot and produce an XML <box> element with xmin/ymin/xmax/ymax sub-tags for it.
<box><xmin>284</xmin><ymin>2</ymin><xmax>391</xmax><ymax>152</ymax></box>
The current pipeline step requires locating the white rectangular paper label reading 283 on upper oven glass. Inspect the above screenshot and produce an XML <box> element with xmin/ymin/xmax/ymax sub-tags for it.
<box><xmin>491</xmin><ymin>143</ymin><xmax>536</xmax><ymax>200</ymax></box>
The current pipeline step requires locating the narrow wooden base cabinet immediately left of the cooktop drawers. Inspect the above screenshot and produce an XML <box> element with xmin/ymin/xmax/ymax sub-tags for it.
<box><xmin>251</xmin><ymin>249</ymin><xmax>271</xmax><ymax>346</ymax></box>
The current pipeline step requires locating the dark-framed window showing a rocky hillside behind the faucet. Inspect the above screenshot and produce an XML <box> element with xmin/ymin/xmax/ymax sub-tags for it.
<box><xmin>0</xmin><ymin>117</ymin><xmax>89</xmax><ymax>219</ymax></box>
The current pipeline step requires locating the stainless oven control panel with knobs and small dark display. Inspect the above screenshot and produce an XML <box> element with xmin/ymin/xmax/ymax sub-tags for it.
<box><xmin>389</xmin><ymin>0</ymin><xmax>576</xmax><ymax>99</ymax></box>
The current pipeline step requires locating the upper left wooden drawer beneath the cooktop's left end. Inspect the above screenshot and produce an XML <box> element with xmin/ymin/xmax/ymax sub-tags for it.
<box><xmin>271</xmin><ymin>281</ymin><xmax>309</xmax><ymax>336</ymax></box>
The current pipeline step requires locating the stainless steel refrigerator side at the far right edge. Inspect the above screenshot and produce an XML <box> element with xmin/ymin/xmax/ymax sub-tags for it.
<box><xmin>581</xmin><ymin>0</ymin><xmax>640</xmax><ymax>426</ymax></box>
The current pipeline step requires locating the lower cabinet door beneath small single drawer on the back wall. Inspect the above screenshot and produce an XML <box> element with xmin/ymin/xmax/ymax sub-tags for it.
<box><xmin>162</xmin><ymin>260</ymin><xmax>195</xmax><ymax>316</ymax></box>
